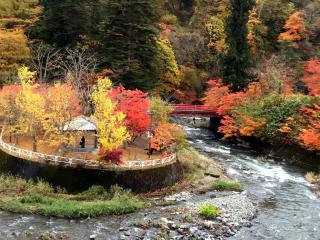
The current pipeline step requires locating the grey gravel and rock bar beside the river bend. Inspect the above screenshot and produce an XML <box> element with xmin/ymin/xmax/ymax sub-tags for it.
<box><xmin>119</xmin><ymin>192</ymin><xmax>257</xmax><ymax>240</ymax></box>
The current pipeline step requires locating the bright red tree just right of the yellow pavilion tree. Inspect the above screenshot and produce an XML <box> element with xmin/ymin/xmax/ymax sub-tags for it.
<box><xmin>111</xmin><ymin>85</ymin><xmax>150</xmax><ymax>140</ymax></box>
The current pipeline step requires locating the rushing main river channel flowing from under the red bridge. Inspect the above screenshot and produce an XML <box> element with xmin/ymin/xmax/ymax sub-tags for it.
<box><xmin>186</xmin><ymin>128</ymin><xmax>320</xmax><ymax>240</ymax></box>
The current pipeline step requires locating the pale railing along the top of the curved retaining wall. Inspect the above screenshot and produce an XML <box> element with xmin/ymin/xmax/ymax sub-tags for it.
<box><xmin>0</xmin><ymin>129</ymin><xmax>176</xmax><ymax>171</ymax></box>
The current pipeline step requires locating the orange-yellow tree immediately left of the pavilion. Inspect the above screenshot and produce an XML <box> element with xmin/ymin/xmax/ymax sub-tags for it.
<box><xmin>43</xmin><ymin>83</ymin><xmax>81</xmax><ymax>147</ymax></box>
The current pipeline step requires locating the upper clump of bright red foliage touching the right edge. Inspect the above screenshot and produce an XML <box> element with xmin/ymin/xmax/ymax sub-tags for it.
<box><xmin>303</xmin><ymin>60</ymin><xmax>320</xmax><ymax>95</ymax></box>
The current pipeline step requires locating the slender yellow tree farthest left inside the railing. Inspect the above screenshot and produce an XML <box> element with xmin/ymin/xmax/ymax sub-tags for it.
<box><xmin>16</xmin><ymin>67</ymin><xmax>45</xmax><ymax>152</ymax></box>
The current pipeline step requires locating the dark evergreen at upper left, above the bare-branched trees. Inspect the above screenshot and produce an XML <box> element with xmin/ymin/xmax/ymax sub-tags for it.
<box><xmin>31</xmin><ymin>0</ymin><xmax>96</xmax><ymax>47</ymax></box>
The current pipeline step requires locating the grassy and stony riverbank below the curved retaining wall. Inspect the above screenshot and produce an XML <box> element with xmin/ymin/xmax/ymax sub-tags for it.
<box><xmin>0</xmin><ymin>145</ymin><xmax>256</xmax><ymax>239</ymax></box>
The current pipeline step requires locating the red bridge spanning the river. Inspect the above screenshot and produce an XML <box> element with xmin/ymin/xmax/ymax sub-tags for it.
<box><xmin>171</xmin><ymin>104</ymin><xmax>219</xmax><ymax>118</ymax></box>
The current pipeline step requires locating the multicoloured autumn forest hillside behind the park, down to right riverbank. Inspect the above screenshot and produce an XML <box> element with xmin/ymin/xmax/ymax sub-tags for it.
<box><xmin>0</xmin><ymin>0</ymin><xmax>320</xmax><ymax>154</ymax></box>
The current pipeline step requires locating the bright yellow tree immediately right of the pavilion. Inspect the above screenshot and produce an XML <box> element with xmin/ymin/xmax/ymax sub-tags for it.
<box><xmin>92</xmin><ymin>78</ymin><xmax>130</xmax><ymax>152</ymax></box>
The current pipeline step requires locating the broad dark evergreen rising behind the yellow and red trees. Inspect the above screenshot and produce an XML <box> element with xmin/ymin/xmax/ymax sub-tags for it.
<box><xmin>100</xmin><ymin>0</ymin><xmax>159</xmax><ymax>90</ymax></box>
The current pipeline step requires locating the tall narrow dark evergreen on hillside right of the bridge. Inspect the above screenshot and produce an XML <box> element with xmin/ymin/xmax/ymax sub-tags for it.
<box><xmin>222</xmin><ymin>0</ymin><xmax>253</xmax><ymax>91</ymax></box>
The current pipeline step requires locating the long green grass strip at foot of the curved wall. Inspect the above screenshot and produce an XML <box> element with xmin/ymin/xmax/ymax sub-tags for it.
<box><xmin>0</xmin><ymin>175</ymin><xmax>143</xmax><ymax>218</ymax></box>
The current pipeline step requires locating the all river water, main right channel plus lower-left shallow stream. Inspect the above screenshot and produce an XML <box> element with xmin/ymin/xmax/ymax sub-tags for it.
<box><xmin>0</xmin><ymin>127</ymin><xmax>320</xmax><ymax>240</ymax></box>
